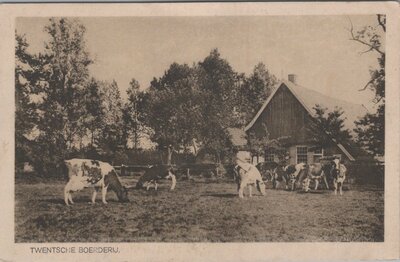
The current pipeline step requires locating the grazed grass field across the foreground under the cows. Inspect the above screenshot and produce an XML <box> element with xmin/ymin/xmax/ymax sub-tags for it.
<box><xmin>15</xmin><ymin>177</ymin><xmax>384</xmax><ymax>242</ymax></box>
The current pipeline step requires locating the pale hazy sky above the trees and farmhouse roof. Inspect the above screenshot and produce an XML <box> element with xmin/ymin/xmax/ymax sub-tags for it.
<box><xmin>16</xmin><ymin>15</ymin><xmax>384</xmax><ymax>108</ymax></box>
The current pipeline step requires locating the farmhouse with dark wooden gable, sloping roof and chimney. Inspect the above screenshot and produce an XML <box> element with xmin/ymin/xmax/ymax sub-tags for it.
<box><xmin>229</xmin><ymin>75</ymin><xmax>367</xmax><ymax>164</ymax></box>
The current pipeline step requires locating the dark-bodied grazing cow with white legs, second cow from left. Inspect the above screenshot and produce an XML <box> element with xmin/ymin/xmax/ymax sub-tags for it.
<box><xmin>136</xmin><ymin>165</ymin><xmax>176</xmax><ymax>190</ymax></box>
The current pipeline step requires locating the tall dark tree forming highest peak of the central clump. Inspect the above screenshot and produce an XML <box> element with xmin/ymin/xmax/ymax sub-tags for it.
<box><xmin>197</xmin><ymin>49</ymin><xmax>239</xmax><ymax>159</ymax></box>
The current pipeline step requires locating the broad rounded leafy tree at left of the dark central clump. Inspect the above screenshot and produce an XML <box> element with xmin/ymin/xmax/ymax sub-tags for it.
<box><xmin>143</xmin><ymin>63</ymin><xmax>201</xmax><ymax>163</ymax></box>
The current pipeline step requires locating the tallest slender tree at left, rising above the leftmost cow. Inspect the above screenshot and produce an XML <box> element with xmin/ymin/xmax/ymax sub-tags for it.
<box><xmin>34</xmin><ymin>18</ymin><xmax>92</xmax><ymax>172</ymax></box>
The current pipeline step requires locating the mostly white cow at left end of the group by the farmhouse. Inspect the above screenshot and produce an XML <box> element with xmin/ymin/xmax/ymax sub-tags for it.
<box><xmin>235</xmin><ymin>159</ymin><xmax>265</xmax><ymax>198</ymax></box>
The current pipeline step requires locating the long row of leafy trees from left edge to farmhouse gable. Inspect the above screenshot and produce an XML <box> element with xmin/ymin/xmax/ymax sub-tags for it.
<box><xmin>15</xmin><ymin>18</ymin><xmax>384</xmax><ymax>174</ymax></box>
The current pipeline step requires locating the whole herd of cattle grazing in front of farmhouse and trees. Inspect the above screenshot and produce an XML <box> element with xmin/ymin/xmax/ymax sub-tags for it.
<box><xmin>62</xmin><ymin>158</ymin><xmax>346</xmax><ymax>205</ymax></box>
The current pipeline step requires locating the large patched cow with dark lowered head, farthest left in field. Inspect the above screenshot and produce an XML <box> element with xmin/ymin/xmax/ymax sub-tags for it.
<box><xmin>63</xmin><ymin>158</ymin><xmax>129</xmax><ymax>205</ymax></box>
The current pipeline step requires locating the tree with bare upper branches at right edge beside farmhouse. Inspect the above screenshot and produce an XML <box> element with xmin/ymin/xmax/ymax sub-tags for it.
<box><xmin>350</xmin><ymin>14</ymin><xmax>386</xmax><ymax>155</ymax></box>
